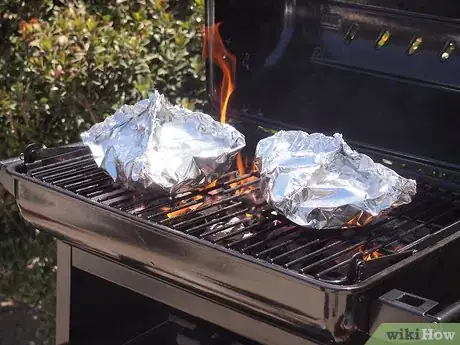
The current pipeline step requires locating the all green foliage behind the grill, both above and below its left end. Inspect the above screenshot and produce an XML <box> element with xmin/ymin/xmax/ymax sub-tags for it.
<box><xmin>0</xmin><ymin>0</ymin><xmax>205</xmax><ymax>343</ymax></box>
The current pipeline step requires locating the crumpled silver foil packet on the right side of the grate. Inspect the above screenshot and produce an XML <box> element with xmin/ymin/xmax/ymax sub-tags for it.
<box><xmin>256</xmin><ymin>131</ymin><xmax>417</xmax><ymax>229</ymax></box>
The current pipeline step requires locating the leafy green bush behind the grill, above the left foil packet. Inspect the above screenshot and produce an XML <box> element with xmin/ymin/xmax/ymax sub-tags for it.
<box><xmin>0</xmin><ymin>0</ymin><xmax>204</xmax><ymax>155</ymax></box>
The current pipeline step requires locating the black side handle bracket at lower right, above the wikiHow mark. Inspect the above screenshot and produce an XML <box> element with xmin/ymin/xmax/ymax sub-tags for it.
<box><xmin>370</xmin><ymin>289</ymin><xmax>460</xmax><ymax>334</ymax></box>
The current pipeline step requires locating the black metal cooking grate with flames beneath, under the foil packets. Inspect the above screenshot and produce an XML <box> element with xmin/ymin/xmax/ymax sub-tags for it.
<box><xmin>27</xmin><ymin>148</ymin><xmax>460</xmax><ymax>284</ymax></box>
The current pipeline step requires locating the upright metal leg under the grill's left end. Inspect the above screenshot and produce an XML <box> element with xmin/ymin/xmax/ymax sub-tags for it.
<box><xmin>56</xmin><ymin>241</ymin><xmax>72</xmax><ymax>345</ymax></box>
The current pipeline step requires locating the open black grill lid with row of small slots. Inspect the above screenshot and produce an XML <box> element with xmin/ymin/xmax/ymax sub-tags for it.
<box><xmin>207</xmin><ymin>0</ymin><xmax>460</xmax><ymax>164</ymax></box>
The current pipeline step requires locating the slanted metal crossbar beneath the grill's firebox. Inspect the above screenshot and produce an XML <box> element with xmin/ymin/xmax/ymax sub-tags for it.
<box><xmin>72</xmin><ymin>248</ymin><xmax>320</xmax><ymax>345</ymax></box>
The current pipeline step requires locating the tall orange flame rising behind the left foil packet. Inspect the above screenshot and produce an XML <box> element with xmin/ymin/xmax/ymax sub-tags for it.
<box><xmin>203</xmin><ymin>23</ymin><xmax>236</xmax><ymax>123</ymax></box>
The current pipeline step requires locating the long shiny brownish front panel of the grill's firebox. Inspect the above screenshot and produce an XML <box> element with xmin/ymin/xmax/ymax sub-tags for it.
<box><xmin>18</xmin><ymin>177</ymin><xmax>330</xmax><ymax>327</ymax></box>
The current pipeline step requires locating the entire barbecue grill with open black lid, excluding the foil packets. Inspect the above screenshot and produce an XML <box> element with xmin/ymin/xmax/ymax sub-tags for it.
<box><xmin>0</xmin><ymin>0</ymin><xmax>460</xmax><ymax>344</ymax></box>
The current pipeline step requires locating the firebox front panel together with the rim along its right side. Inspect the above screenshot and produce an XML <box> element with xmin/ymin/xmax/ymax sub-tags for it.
<box><xmin>10</xmin><ymin>157</ymin><xmax>460</xmax><ymax>340</ymax></box>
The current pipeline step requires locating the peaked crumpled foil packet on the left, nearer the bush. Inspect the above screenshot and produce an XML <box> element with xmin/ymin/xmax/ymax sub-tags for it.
<box><xmin>81</xmin><ymin>91</ymin><xmax>246</xmax><ymax>195</ymax></box>
